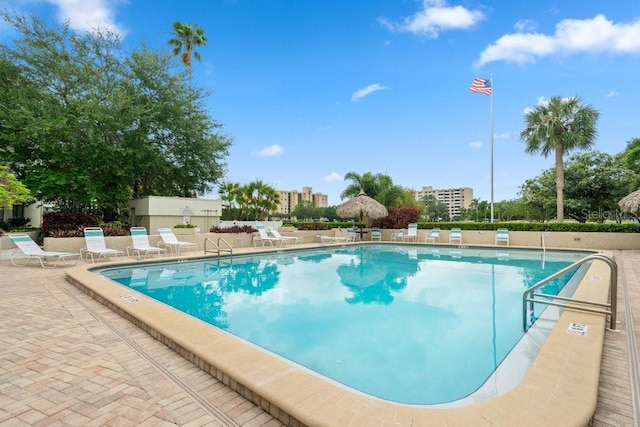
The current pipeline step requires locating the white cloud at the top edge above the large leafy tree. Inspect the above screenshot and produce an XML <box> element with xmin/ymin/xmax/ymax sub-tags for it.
<box><xmin>45</xmin><ymin>0</ymin><xmax>126</xmax><ymax>36</ymax></box>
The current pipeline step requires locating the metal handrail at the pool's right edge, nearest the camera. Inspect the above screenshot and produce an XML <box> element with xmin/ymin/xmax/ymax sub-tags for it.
<box><xmin>522</xmin><ymin>254</ymin><xmax>618</xmax><ymax>332</ymax></box>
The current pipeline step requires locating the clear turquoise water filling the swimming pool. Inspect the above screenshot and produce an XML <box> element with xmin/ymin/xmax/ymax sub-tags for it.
<box><xmin>99</xmin><ymin>245</ymin><xmax>586</xmax><ymax>405</ymax></box>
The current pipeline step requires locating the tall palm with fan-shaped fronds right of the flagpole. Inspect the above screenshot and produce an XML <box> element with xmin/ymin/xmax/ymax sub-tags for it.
<box><xmin>520</xmin><ymin>96</ymin><xmax>600</xmax><ymax>222</ymax></box>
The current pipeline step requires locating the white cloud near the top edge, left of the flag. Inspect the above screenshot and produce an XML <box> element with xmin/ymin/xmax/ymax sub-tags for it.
<box><xmin>378</xmin><ymin>0</ymin><xmax>485</xmax><ymax>38</ymax></box>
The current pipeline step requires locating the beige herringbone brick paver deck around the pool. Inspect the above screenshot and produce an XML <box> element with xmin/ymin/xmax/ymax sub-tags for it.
<box><xmin>0</xmin><ymin>247</ymin><xmax>640</xmax><ymax>427</ymax></box>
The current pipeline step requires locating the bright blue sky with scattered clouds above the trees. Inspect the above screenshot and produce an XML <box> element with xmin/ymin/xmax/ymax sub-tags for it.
<box><xmin>0</xmin><ymin>0</ymin><xmax>640</xmax><ymax>205</ymax></box>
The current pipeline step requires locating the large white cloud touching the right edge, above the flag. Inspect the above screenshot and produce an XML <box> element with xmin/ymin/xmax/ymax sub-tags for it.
<box><xmin>476</xmin><ymin>15</ymin><xmax>640</xmax><ymax>66</ymax></box>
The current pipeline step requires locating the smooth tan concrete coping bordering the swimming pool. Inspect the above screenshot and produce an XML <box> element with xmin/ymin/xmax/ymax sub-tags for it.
<box><xmin>66</xmin><ymin>245</ymin><xmax>610</xmax><ymax>426</ymax></box>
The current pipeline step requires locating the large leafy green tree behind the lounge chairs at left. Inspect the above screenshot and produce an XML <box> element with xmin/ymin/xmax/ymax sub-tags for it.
<box><xmin>0</xmin><ymin>13</ymin><xmax>231</xmax><ymax>215</ymax></box>
